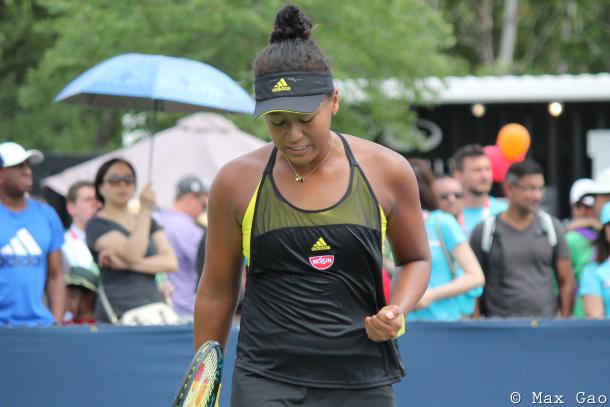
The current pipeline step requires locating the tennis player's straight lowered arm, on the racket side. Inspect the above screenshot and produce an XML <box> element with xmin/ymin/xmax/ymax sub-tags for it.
<box><xmin>194</xmin><ymin>162</ymin><xmax>251</xmax><ymax>349</ymax></box>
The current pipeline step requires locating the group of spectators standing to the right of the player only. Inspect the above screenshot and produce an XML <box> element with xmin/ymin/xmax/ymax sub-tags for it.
<box><xmin>410</xmin><ymin>145</ymin><xmax>610</xmax><ymax>320</ymax></box>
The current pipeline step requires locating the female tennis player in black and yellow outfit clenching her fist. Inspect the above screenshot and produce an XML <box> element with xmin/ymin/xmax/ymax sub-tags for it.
<box><xmin>195</xmin><ymin>6</ymin><xmax>430</xmax><ymax>407</ymax></box>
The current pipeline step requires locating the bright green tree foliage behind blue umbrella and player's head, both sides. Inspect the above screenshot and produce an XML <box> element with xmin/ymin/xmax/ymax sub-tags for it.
<box><xmin>0</xmin><ymin>0</ymin><xmax>457</xmax><ymax>151</ymax></box>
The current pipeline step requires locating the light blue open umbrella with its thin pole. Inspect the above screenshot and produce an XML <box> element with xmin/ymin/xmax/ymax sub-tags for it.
<box><xmin>54</xmin><ymin>54</ymin><xmax>254</xmax><ymax>174</ymax></box>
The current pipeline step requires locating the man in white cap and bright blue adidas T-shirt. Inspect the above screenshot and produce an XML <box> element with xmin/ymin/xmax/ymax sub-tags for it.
<box><xmin>0</xmin><ymin>142</ymin><xmax>66</xmax><ymax>326</ymax></box>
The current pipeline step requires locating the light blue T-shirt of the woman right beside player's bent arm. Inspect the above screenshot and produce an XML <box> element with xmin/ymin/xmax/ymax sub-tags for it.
<box><xmin>407</xmin><ymin>211</ymin><xmax>466</xmax><ymax>321</ymax></box>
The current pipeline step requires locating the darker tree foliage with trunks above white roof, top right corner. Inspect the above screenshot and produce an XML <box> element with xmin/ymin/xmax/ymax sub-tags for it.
<box><xmin>431</xmin><ymin>0</ymin><xmax>610</xmax><ymax>74</ymax></box>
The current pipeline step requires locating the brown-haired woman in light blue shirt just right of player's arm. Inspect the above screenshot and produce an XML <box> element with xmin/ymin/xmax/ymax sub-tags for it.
<box><xmin>409</xmin><ymin>159</ymin><xmax>485</xmax><ymax>321</ymax></box>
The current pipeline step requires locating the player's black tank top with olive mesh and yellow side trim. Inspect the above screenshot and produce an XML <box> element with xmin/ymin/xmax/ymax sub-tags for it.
<box><xmin>236</xmin><ymin>135</ymin><xmax>405</xmax><ymax>388</ymax></box>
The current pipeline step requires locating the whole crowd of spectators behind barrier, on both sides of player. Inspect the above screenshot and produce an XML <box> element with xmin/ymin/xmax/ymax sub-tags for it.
<box><xmin>0</xmin><ymin>142</ymin><xmax>610</xmax><ymax>326</ymax></box>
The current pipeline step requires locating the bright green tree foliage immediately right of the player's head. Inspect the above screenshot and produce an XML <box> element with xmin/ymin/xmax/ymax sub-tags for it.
<box><xmin>306</xmin><ymin>1</ymin><xmax>459</xmax><ymax>147</ymax></box>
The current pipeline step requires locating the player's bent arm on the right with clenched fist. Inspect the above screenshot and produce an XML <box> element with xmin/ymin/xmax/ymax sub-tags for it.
<box><xmin>365</xmin><ymin>153</ymin><xmax>431</xmax><ymax>341</ymax></box>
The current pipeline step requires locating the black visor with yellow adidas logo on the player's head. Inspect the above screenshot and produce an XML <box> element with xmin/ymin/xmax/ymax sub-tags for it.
<box><xmin>252</xmin><ymin>72</ymin><xmax>335</xmax><ymax>120</ymax></box>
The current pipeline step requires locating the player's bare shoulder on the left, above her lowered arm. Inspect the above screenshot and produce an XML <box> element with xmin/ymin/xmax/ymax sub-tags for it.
<box><xmin>210</xmin><ymin>143</ymin><xmax>273</xmax><ymax>219</ymax></box>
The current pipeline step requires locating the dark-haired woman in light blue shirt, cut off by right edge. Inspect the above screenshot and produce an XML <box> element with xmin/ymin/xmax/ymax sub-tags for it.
<box><xmin>579</xmin><ymin>202</ymin><xmax>610</xmax><ymax>318</ymax></box>
